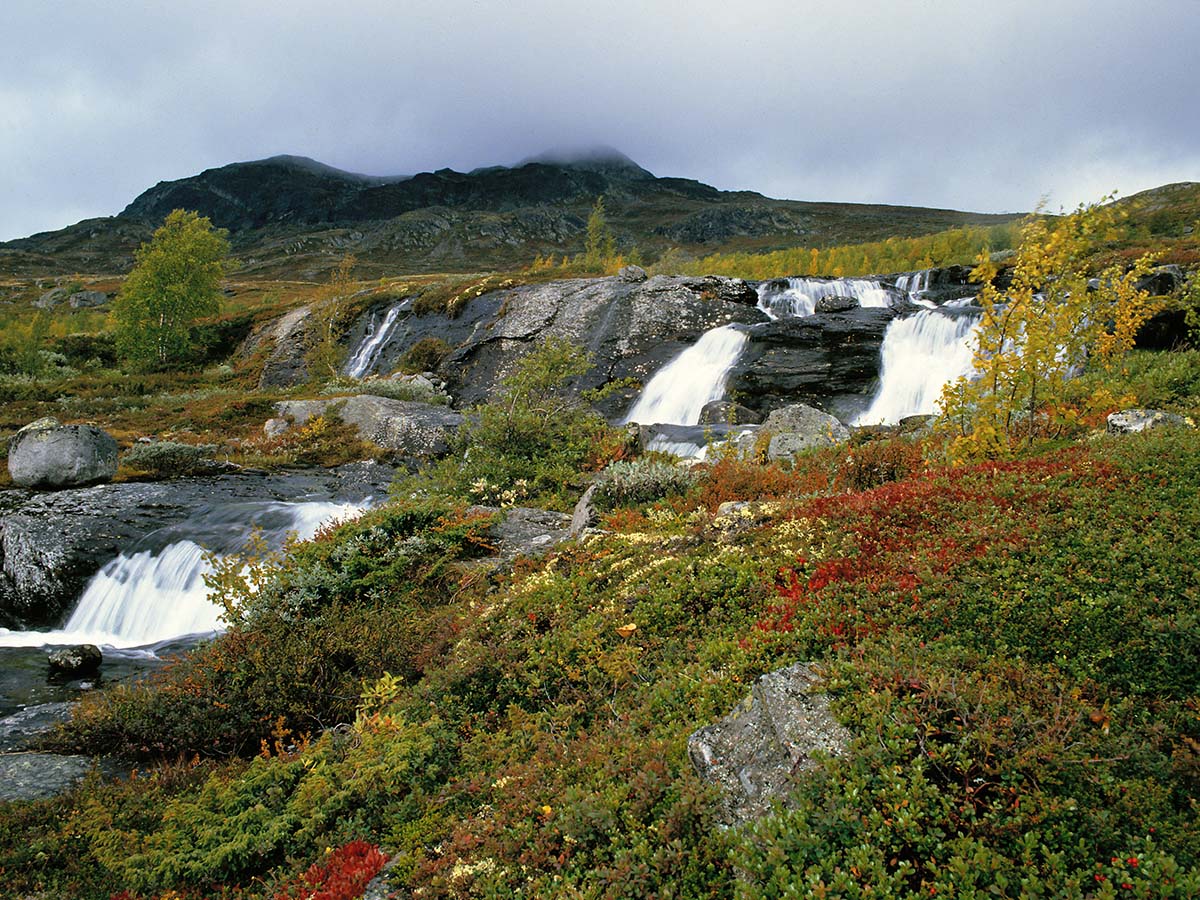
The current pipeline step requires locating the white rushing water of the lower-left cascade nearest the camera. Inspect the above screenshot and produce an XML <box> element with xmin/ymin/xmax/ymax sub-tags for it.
<box><xmin>0</xmin><ymin>500</ymin><xmax>365</xmax><ymax>649</ymax></box>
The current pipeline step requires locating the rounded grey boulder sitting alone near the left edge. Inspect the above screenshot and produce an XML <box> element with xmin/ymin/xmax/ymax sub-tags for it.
<box><xmin>8</xmin><ymin>419</ymin><xmax>116</xmax><ymax>488</ymax></box>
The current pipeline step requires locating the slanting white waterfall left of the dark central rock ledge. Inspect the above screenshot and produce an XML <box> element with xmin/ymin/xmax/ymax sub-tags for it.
<box><xmin>625</xmin><ymin>325</ymin><xmax>749</xmax><ymax>425</ymax></box>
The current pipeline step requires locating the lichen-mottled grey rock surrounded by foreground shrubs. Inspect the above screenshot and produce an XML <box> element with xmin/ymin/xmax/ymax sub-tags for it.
<box><xmin>688</xmin><ymin>664</ymin><xmax>851</xmax><ymax>826</ymax></box>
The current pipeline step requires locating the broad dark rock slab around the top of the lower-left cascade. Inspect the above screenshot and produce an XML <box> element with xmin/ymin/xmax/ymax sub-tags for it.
<box><xmin>0</xmin><ymin>463</ymin><xmax>395</xmax><ymax>628</ymax></box>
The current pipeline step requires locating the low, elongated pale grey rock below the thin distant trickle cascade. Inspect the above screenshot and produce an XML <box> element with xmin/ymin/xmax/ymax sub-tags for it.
<box><xmin>275</xmin><ymin>394</ymin><xmax>463</xmax><ymax>458</ymax></box>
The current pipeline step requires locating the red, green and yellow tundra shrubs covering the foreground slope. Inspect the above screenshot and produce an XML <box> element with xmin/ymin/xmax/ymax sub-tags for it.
<box><xmin>0</xmin><ymin>199</ymin><xmax>1200</xmax><ymax>900</ymax></box>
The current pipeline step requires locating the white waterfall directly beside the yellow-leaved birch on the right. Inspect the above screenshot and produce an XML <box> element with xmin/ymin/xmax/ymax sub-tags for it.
<box><xmin>854</xmin><ymin>310</ymin><xmax>979</xmax><ymax>425</ymax></box>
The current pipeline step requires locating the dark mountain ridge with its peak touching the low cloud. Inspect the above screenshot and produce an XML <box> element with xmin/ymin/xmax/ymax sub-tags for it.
<box><xmin>0</xmin><ymin>148</ymin><xmax>1027</xmax><ymax>278</ymax></box>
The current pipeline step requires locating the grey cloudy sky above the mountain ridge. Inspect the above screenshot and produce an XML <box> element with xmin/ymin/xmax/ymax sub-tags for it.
<box><xmin>0</xmin><ymin>0</ymin><xmax>1200</xmax><ymax>240</ymax></box>
